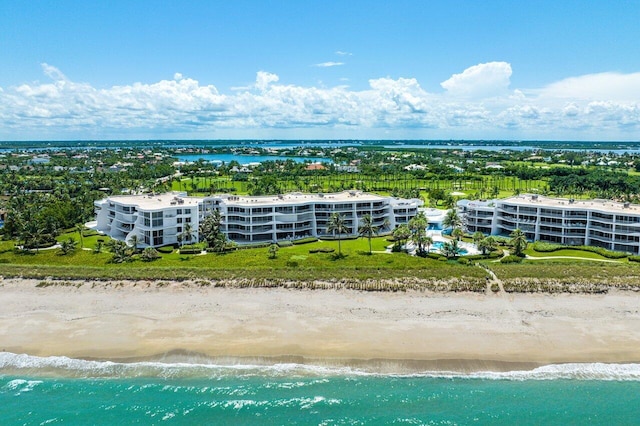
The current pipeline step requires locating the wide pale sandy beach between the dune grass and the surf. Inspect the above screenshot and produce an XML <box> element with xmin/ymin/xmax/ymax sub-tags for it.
<box><xmin>0</xmin><ymin>279</ymin><xmax>640</xmax><ymax>370</ymax></box>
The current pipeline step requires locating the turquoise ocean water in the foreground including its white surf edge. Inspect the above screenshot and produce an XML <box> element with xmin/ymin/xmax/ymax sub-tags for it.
<box><xmin>0</xmin><ymin>353</ymin><xmax>640</xmax><ymax>425</ymax></box>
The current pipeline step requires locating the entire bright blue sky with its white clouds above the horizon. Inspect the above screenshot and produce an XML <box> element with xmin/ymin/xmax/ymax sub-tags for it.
<box><xmin>0</xmin><ymin>0</ymin><xmax>640</xmax><ymax>140</ymax></box>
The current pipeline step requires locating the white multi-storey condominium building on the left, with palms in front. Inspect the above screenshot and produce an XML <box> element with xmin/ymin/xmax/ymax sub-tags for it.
<box><xmin>94</xmin><ymin>191</ymin><xmax>423</xmax><ymax>247</ymax></box>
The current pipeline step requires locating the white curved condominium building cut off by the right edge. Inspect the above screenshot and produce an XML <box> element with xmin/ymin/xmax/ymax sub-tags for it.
<box><xmin>458</xmin><ymin>195</ymin><xmax>640</xmax><ymax>254</ymax></box>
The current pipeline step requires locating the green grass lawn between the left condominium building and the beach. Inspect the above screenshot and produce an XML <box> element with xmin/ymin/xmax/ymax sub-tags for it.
<box><xmin>0</xmin><ymin>233</ymin><xmax>485</xmax><ymax>281</ymax></box>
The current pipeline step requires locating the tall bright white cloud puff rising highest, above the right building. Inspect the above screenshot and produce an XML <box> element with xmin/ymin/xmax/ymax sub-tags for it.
<box><xmin>440</xmin><ymin>62</ymin><xmax>511</xmax><ymax>97</ymax></box>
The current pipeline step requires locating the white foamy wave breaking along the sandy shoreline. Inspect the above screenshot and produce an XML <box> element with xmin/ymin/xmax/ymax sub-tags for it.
<box><xmin>0</xmin><ymin>352</ymin><xmax>640</xmax><ymax>382</ymax></box>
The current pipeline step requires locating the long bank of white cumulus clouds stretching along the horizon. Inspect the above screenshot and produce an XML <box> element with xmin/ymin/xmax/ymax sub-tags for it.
<box><xmin>0</xmin><ymin>62</ymin><xmax>640</xmax><ymax>139</ymax></box>
